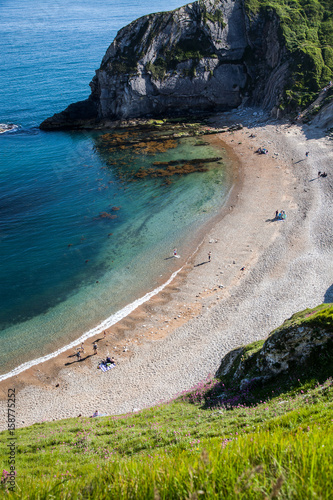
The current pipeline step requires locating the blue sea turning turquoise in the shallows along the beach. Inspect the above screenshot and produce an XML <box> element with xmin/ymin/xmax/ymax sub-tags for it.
<box><xmin>0</xmin><ymin>0</ymin><xmax>230</xmax><ymax>374</ymax></box>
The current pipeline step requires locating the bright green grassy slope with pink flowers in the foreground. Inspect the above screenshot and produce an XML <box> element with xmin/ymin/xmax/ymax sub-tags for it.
<box><xmin>0</xmin><ymin>306</ymin><xmax>333</xmax><ymax>499</ymax></box>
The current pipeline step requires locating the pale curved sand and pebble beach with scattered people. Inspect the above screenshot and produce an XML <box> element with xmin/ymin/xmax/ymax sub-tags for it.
<box><xmin>0</xmin><ymin>109</ymin><xmax>333</xmax><ymax>430</ymax></box>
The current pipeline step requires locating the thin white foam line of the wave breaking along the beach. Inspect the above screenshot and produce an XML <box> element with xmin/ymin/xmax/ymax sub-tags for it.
<box><xmin>0</xmin><ymin>267</ymin><xmax>183</xmax><ymax>382</ymax></box>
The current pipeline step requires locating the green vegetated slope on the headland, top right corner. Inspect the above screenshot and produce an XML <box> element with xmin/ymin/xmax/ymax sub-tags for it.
<box><xmin>245</xmin><ymin>0</ymin><xmax>333</xmax><ymax>108</ymax></box>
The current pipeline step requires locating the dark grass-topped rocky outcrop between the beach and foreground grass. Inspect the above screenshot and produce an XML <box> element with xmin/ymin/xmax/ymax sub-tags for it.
<box><xmin>217</xmin><ymin>304</ymin><xmax>333</xmax><ymax>388</ymax></box>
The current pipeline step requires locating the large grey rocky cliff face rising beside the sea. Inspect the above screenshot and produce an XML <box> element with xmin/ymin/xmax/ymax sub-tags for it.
<box><xmin>41</xmin><ymin>0</ymin><xmax>288</xmax><ymax>129</ymax></box>
